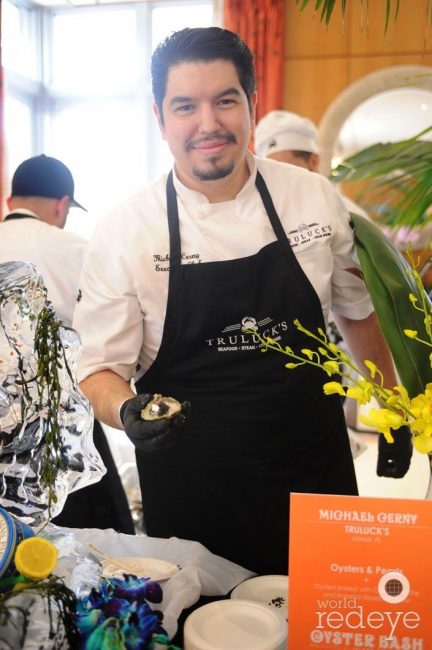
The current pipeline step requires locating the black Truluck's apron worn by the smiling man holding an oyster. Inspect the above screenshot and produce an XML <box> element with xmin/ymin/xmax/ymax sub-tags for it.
<box><xmin>136</xmin><ymin>174</ymin><xmax>357</xmax><ymax>574</ymax></box>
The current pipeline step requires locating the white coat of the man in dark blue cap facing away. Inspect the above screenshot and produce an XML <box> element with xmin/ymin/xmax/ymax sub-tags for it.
<box><xmin>0</xmin><ymin>209</ymin><xmax>88</xmax><ymax>326</ymax></box>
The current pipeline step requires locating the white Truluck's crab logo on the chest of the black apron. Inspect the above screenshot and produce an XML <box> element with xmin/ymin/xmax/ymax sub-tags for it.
<box><xmin>206</xmin><ymin>316</ymin><xmax>288</xmax><ymax>352</ymax></box>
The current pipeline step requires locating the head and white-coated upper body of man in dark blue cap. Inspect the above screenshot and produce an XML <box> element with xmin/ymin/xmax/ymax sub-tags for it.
<box><xmin>0</xmin><ymin>154</ymin><xmax>88</xmax><ymax>326</ymax></box>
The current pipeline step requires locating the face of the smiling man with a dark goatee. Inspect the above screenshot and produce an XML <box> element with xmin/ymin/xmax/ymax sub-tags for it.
<box><xmin>154</xmin><ymin>59</ymin><xmax>256</xmax><ymax>194</ymax></box>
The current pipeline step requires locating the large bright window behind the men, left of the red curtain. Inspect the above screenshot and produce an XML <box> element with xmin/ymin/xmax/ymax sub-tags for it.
<box><xmin>2</xmin><ymin>0</ymin><xmax>213</xmax><ymax>237</ymax></box>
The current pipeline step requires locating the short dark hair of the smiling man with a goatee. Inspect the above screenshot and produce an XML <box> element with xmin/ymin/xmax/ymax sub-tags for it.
<box><xmin>151</xmin><ymin>27</ymin><xmax>256</xmax><ymax>115</ymax></box>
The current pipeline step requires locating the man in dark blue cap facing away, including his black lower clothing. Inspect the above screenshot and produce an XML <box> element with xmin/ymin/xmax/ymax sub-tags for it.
<box><xmin>0</xmin><ymin>154</ymin><xmax>135</xmax><ymax>534</ymax></box>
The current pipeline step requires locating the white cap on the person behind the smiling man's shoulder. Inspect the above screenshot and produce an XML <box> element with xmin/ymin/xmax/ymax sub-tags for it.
<box><xmin>254</xmin><ymin>111</ymin><xmax>318</xmax><ymax>157</ymax></box>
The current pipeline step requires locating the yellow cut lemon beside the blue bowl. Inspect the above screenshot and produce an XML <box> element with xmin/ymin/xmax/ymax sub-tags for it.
<box><xmin>15</xmin><ymin>537</ymin><xmax>58</xmax><ymax>580</ymax></box>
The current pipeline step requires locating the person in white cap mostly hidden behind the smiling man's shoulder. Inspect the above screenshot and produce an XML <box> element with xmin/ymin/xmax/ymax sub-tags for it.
<box><xmin>254</xmin><ymin>111</ymin><xmax>369</xmax><ymax>219</ymax></box>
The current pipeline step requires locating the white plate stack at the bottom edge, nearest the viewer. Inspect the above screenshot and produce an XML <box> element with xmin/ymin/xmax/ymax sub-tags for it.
<box><xmin>183</xmin><ymin>600</ymin><xmax>286</xmax><ymax>650</ymax></box>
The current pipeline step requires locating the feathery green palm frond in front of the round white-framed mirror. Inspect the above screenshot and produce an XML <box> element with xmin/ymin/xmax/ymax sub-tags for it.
<box><xmin>330</xmin><ymin>126</ymin><xmax>432</xmax><ymax>228</ymax></box>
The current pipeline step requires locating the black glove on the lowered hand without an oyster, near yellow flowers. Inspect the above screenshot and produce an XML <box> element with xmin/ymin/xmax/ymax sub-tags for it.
<box><xmin>377</xmin><ymin>426</ymin><xmax>413</xmax><ymax>478</ymax></box>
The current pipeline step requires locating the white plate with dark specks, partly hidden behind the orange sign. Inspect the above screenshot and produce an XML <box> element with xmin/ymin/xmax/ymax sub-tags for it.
<box><xmin>231</xmin><ymin>575</ymin><xmax>288</xmax><ymax>620</ymax></box>
